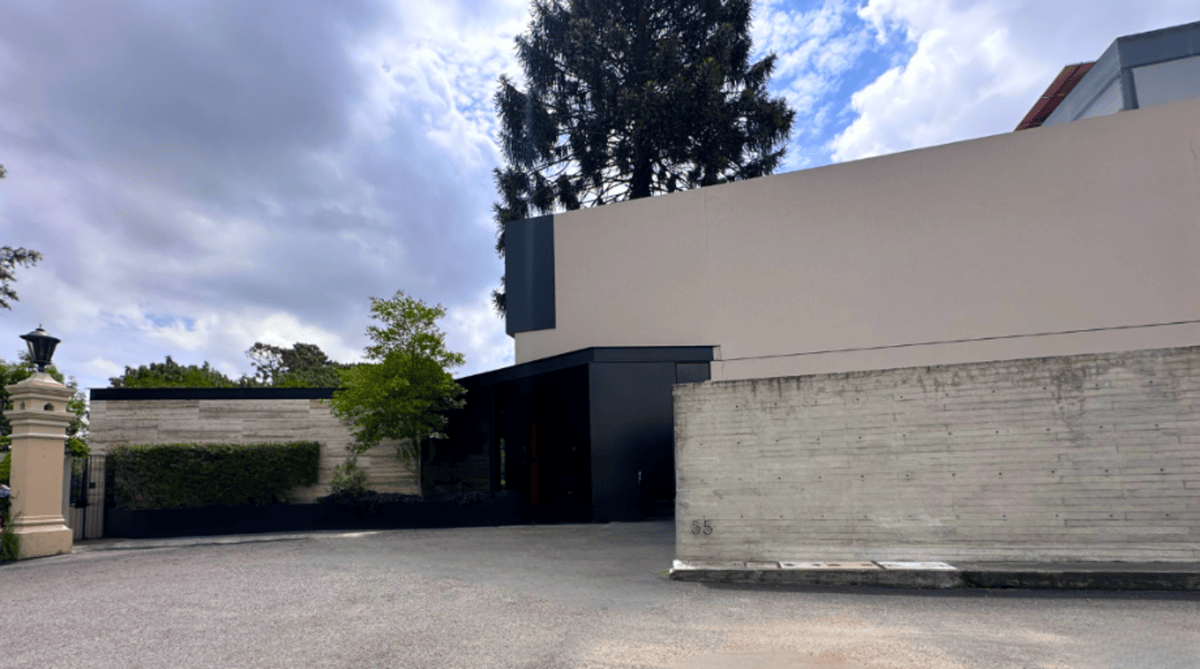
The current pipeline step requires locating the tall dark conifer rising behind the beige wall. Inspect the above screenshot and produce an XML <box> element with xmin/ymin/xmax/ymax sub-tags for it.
<box><xmin>492</xmin><ymin>0</ymin><xmax>796</xmax><ymax>313</ymax></box>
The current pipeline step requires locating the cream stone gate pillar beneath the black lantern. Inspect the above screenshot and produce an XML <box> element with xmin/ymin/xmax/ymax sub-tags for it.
<box><xmin>7</xmin><ymin>372</ymin><xmax>74</xmax><ymax>559</ymax></box>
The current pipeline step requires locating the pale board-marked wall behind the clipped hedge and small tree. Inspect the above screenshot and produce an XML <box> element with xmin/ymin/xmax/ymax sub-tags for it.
<box><xmin>88</xmin><ymin>399</ymin><xmax>418</xmax><ymax>502</ymax></box>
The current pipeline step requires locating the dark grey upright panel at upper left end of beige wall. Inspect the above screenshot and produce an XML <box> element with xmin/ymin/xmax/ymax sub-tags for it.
<box><xmin>504</xmin><ymin>215</ymin><xmax>554</xmax><ymax>335</ymax></box>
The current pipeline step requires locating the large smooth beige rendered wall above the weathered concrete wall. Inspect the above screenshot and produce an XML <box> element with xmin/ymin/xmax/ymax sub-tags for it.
<box><xmin>516</xmin><ymin>100</ymin><xmax>1200</xmax><ymax>380</ymax></box>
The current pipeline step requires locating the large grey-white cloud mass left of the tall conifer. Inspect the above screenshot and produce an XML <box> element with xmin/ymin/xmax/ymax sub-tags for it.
<box><xmin>0</xmin><ymin>0</ymin><xmax>526</xmax><ymax>386</ymax></box>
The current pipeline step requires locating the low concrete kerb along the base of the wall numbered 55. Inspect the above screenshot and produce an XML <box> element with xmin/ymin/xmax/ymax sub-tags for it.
<box><xmin>670</xmin><ymin>560</ymin><xmax>1200</xmax><ymax>591</ymax></box>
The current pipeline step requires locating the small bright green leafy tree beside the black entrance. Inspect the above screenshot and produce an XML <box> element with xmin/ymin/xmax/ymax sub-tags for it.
<box><xmin>330</xmin><ymin>291</ymin><xmax>466</xmax><ymax>493</ymax></box>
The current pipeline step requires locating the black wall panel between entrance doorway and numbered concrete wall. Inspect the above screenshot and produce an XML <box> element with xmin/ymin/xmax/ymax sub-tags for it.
<box><xmin>588</xmin><ymin>362</ymin><xmax>676</xmax><ymax>520</ymax></box>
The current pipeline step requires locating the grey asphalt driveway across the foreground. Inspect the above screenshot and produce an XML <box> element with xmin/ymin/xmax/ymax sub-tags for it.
<box><xmin>0</xmin><ymin>523</ymin><xmax>1200</xmax><ymax>669</ymax></box>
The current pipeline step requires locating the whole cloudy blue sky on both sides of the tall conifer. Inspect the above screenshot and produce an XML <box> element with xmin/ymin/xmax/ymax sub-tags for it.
<box><xmin>0</xmin><ymin>0</ymin><xmax>1200</xmax><ymax>388</ymax></box>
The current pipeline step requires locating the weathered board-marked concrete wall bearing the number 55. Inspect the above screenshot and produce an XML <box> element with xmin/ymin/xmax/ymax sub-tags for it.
<box><xmin>674</xmin><ymin>346</ymin><xmax>1200</xmax><ymax>561</ymax></box>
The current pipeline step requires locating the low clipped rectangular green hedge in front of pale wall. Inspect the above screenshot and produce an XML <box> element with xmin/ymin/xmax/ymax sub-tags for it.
<box><xmin>104</xmin><ymin>441</ymin><xmax>320</xmax><ymax>510</ymax></box>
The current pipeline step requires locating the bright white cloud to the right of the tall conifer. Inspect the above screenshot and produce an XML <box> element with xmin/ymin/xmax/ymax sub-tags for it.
<box><xmin>830</xmin><ymin>0</ymin><xmax>1195</xmax><ymax>161</ymax></box>
